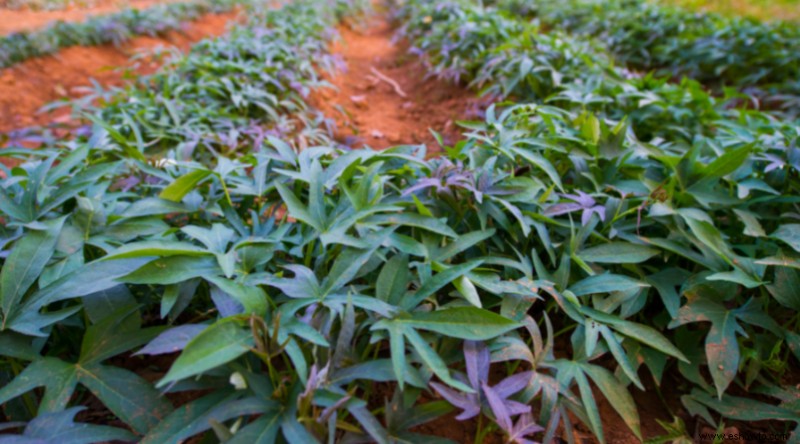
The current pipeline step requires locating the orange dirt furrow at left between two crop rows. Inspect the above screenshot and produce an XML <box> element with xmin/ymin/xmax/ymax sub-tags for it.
<box><xmin>0</xmin><ymin>12</ymin><xmax>239</xmax><ymax>133</ymax></box>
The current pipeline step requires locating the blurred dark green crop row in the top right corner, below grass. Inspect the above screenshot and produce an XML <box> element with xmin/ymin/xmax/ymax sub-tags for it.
<box><xmin>496</xmin><ymin>0</ymin><xmax>800</xmax><ymax>109</ymax></box>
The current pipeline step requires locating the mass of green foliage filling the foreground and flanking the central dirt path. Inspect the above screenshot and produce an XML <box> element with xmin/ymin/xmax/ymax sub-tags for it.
<box><xmin>0</xmin><ymin>0</ymin><xmax>800</xmax><ymax>443</ymax></box>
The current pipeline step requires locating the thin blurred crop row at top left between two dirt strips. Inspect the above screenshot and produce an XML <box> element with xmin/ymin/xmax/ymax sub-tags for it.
<box><xmin>0</xmin><ymin>0</ymin><xmax>241</xmax><ymax>68</ymax></box>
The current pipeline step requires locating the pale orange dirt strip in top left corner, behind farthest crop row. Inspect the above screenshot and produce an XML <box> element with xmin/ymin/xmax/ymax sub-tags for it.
<box><xmin>0</xmin><ymin>0</ymin><xmax>188</xmax><ymax>36</ymax></box>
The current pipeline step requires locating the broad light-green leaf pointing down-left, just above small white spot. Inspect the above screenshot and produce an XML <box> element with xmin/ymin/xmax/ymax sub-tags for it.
<box><xmin>156</xmin><ymin>317</ymin><xmax>253</xmax><ymax>388</ymax></box>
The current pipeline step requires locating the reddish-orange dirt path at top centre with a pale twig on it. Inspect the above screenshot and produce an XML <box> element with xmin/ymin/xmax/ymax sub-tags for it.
<box><xmin>312</xmin><ymin>17</ymin><xmax>479</xmax><ymax>152</ymax></box>
